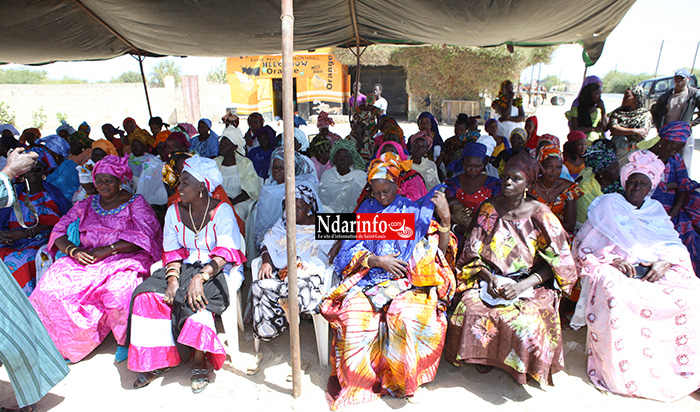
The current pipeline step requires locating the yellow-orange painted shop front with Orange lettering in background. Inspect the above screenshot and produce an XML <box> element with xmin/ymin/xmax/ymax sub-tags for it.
<box><xmin>226</xmin><ymin>49</ymin><xmax>350</xmax><ymax>119</ymax></box>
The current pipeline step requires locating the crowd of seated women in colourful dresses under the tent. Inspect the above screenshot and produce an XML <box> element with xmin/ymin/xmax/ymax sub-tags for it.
<box><xmin>0</xmin><ymin>78</ymin><xmax>700</xmax><ymax>409</ymax></box>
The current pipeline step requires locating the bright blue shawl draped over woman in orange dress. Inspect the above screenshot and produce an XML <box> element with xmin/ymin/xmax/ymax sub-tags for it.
<box><xmin>333</xmin><ymin>184</ymin><xmax>446</xmax><ymax>287</ymax></box>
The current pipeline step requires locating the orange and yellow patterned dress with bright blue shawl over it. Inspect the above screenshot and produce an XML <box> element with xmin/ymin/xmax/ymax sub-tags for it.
<box><xmin>321</xmin><ymin>190</ymin><xmax>456</xmax><ymax>410</ymax></box>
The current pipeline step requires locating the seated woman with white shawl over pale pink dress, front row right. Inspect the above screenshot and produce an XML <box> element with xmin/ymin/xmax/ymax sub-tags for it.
<box><xmin>573</xmin><ymin>150</ymin><xmax>700</xmax><ymax>402</ymax></box>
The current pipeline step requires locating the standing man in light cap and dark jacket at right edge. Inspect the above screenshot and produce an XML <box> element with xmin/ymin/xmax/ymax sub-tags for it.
<box><xmin>651</xmin><ymin>69</ymin><xmax>700</xmax><ymax>169</ymax></box>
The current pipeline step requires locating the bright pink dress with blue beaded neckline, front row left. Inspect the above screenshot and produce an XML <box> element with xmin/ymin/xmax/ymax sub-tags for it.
<box><xmin>30</xmin><ymin>195</ymin><xmax>162</xmax><ymax>362</ymax></box>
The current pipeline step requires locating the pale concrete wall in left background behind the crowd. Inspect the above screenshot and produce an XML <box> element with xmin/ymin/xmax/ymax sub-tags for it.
<box><xmin>0</xmin><ymin>76</ymin><xmax>231</xmax><ymax>139</ymax></box>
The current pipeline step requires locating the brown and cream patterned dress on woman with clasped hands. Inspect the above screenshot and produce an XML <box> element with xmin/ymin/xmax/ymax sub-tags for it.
<box><xmin>445</xmin><ymin>201</ymin><xmax>577</xmax><ymax>385</ymax></box>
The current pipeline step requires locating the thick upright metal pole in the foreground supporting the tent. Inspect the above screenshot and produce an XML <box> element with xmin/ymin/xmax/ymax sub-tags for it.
<box><xmin>281</xmin><ymin>0</ymin><xmax>301</xmax><ymax>398</ymax></box>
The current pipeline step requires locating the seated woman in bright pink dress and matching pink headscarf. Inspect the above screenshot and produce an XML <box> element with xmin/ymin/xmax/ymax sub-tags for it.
<box><xmin>30</xmin><ymin>155</ymin><xmax>163</xmax><ymax>362</ymax></box>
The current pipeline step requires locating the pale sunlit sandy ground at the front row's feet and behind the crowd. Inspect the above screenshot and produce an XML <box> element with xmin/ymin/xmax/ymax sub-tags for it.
<box><xmin>0</xmin><ymin>98</ymin><xmax>700</xmax><ymax>412</ymax></box>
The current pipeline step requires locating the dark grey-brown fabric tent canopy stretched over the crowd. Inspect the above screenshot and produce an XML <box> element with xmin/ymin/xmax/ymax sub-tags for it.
<box><xmin>0</xmin><ymin>0</ymin><xmax>634</xmax><ymax>64</ymax></box>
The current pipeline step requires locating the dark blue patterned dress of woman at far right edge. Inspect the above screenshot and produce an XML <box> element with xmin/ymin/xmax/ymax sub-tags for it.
<box><xmin>651</xmin><ymin>154</ymin><xmax>700</xmax><ymax>277</ymax></box>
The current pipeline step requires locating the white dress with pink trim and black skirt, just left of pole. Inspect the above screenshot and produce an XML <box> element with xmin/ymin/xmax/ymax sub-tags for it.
<box><xmin>128</xmin><ymin>202</ymin><xmax>245</xmax><ymax>372</ymax></box>
